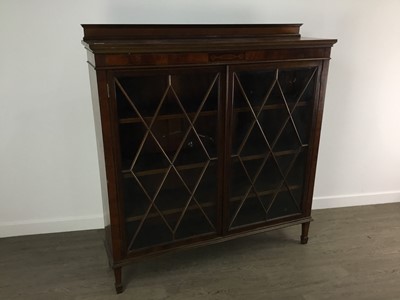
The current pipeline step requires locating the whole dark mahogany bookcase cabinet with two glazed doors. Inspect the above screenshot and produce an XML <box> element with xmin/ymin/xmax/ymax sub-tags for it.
<box><xmin>82</xmin><ymin>24</ymin><xmax>336</xmax><ymax>293</ymax></box>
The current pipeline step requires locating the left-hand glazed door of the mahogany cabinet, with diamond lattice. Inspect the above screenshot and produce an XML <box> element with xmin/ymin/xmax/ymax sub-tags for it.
<box><xmin>109</xmin><ymin>67</ymin><xmax>225</xmax><ymax>255</ymax></box>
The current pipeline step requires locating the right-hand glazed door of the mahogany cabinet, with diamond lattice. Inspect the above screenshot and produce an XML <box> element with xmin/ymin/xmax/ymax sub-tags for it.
<box><xmin>227</xmin><ymin>63</ymin><xmax>320</xmax><ymax>230</ymax></box>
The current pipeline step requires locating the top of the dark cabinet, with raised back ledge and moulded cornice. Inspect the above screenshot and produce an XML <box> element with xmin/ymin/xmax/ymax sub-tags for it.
<box><xmin>82</xmin><ymin>24</ymin><xmax>336</xmax><ymax>53</ymax></box>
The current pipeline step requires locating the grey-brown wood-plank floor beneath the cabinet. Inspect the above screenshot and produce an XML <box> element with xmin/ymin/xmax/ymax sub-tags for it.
<box><xmin>0</xmin><ymin>203</ymin><xmax>400</xmax><ymax>300</ymax></box>
